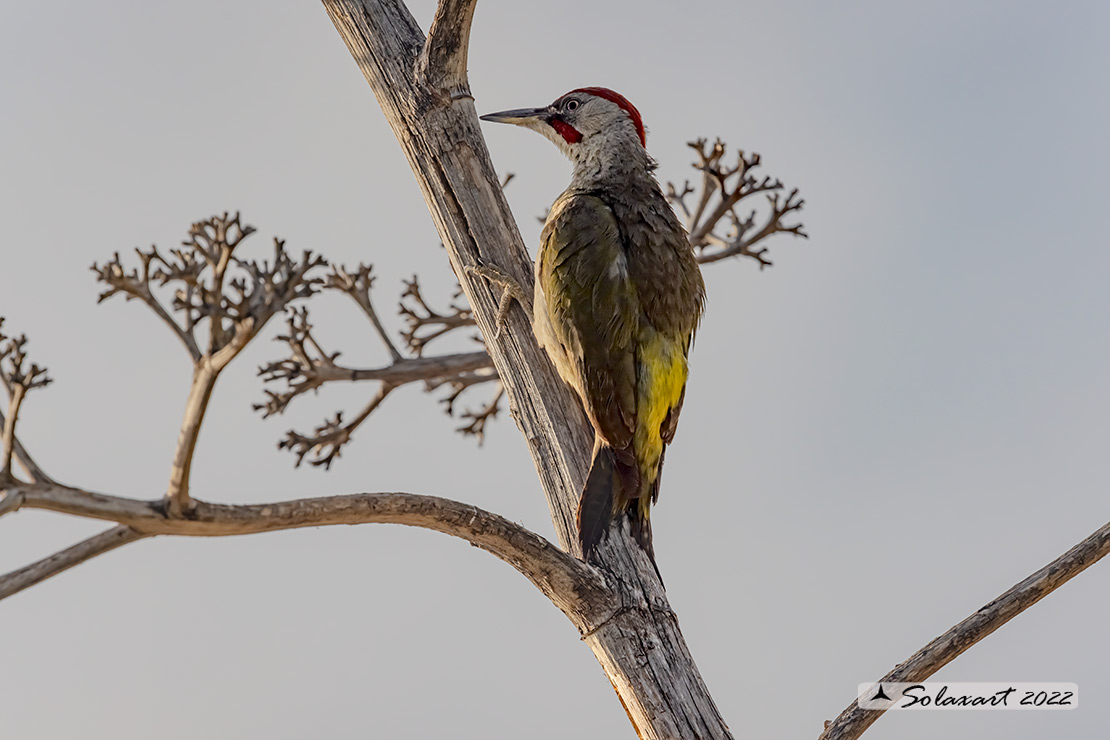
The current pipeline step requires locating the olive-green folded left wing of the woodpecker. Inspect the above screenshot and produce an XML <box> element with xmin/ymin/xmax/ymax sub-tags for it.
<box><xmin>536</xmin><ymin>194</ymin><xmax>640</xmax><ymax>450</ymax></box>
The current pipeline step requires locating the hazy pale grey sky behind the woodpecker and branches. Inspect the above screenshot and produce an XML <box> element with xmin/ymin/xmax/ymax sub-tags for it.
<box><xmin>0</xmin><ymin>0</ymin><xmax>1110</xmax><ymax>740</ymax></box>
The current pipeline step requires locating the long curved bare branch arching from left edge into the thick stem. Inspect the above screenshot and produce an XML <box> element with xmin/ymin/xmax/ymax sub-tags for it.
<box><xmin>0</xmin><ymin>485</ymin><xmax>617</xmax><ymax>632</ymax></box>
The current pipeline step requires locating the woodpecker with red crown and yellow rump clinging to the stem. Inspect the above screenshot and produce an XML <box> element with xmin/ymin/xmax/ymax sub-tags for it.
<box><xmin>482</xmin><ymin>88</ymin><xmax>705</xmax><ymax>564</ymax></box>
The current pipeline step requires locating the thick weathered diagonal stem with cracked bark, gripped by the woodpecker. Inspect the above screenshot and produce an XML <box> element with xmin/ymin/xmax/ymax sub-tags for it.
<box><xmin>324</xmin><ymin>0</ymin><xmax>731</xmax><ymax>740</ymax></box>
